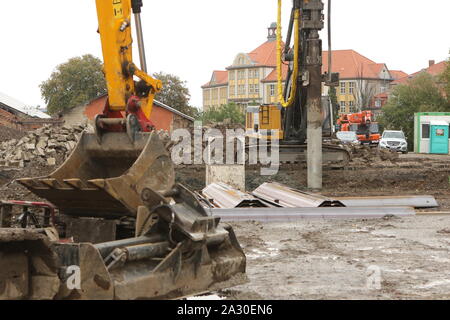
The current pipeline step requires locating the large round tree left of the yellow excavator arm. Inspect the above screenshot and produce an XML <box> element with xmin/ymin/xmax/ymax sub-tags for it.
<box><xmin>39</xmin><ymin>54</ymin><xmax>106</xmax><ymax>114</ymax></box>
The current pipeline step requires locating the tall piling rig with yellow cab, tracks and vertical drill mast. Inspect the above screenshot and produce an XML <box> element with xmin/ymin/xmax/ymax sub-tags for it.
<box><xmin>246</xmin><ymin>0</ymin><xmax>350</xmax><ymax>189</ymax></box>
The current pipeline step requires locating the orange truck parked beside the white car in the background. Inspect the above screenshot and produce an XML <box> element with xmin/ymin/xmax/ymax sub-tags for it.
<box><xmin>337</xmin><ymin>111</ymin><xmax>381</xmax><ymax>145</ymax></box>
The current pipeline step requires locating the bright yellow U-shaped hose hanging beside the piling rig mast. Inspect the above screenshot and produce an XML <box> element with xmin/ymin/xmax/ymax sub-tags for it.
<box><xmin>277</xmin><ymin>0</ymin><xmax>300</xmax><ymax>108</ymax></box>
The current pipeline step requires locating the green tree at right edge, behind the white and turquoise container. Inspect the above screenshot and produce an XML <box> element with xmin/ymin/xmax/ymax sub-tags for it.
<box><xmin>379</xmin><ymin>72</ymin><xmax>450</xmax><ymax>147</ymax></box>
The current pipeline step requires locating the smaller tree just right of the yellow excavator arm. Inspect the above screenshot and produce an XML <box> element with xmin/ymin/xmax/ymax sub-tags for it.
<box><xmin>153</xmin><ymin>72</ymin><xmax>196</xmax><ymax>116</ymax></box>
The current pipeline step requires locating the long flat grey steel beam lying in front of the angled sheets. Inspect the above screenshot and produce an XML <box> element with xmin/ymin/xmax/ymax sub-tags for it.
<box><xmin>211</xmin><ymin>207</ymin><xmax>416</xmax><ymax>222</ymax></box>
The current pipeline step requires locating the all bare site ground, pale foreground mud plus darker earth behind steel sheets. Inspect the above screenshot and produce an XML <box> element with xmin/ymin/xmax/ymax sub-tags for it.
<box><xmin>0</xmin><ymin>149</ymin><xmax>450</xmax><ymax>299</ymax></box>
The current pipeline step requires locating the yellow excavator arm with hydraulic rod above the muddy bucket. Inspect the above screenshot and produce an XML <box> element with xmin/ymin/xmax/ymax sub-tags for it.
<box><xmin>96</xmin><ymin>0</ymin><xmax>162</xmax><ymax>131</ymax></box>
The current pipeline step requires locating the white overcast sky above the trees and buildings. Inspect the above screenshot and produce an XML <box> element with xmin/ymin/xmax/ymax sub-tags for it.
<box><xmin>0</xmin><ymin>0</ymin><xmax>450</xmax><ymax>107</ymax></box>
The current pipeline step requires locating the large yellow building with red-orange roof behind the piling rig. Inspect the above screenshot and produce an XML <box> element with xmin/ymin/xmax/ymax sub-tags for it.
<box><xmin>202</xmin><ymin>23</ymin><xmax>407</xmax><ymax>113</ymax></box>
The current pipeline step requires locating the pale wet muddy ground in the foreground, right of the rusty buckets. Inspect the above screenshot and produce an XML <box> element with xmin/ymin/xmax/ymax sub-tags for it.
<box><xmin>221</xmin><ymin>216</ymin><xmax>450</xmax><ymax>299</ymax></box>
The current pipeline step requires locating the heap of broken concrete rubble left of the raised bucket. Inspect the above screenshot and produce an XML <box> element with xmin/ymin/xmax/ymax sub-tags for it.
<box><xmin>0</xmin><ymin>125</ymin><xmax>86</xmax><ymax>168</ymax></box>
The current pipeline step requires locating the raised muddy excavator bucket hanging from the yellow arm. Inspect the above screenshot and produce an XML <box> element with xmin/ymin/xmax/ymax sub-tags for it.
<box><xmin>18</xmin><ymin>132</ymin><xmax>175</xmax><ymax>218</ymax></box>
